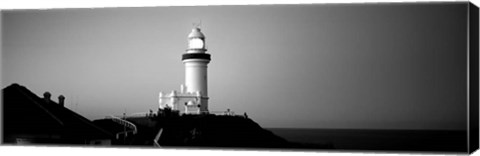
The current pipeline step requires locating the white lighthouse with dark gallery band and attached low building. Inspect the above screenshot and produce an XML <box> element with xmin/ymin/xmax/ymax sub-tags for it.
<box><xmin>158</xmin><ymin>28</ymin><xmax>210</xmax><ymax>113</ymax></box>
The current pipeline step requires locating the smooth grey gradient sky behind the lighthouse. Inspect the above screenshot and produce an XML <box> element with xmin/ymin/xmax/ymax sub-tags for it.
<box><xmin>2</xmin><ymin>2</ymin><xmax>467</xmax><ymax>129</ymax></box>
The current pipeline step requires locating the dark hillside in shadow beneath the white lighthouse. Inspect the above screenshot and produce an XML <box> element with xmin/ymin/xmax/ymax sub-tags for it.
<box><xmin>113</xmin><ymin>114</ymin><xmax>333</xmax><ymax>149</ymax></box>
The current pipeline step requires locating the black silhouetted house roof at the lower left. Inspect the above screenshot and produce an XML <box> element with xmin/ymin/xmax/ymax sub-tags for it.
<box><xmin>2</xmin><ymin>84</ymin><xmax>114</xmax><ymax>144</ymax></box>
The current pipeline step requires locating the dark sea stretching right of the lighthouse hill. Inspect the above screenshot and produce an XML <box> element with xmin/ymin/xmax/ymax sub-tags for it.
<box><xmin>266</xmin><ymin>128</ymin><xmax>467</xmax><ymax>153</ymax></box>
